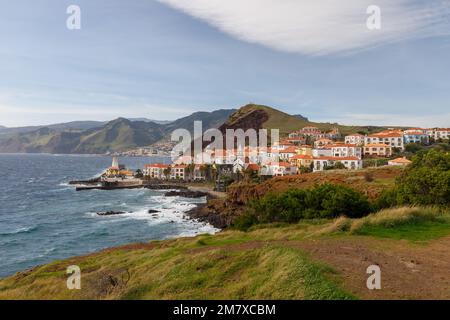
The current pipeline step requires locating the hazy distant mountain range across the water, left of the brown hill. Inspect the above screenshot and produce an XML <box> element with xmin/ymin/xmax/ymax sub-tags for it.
<box><xmin>0</xmin><ymin>110</ymin><xmax>235</xmax><ymax>154</ymax></box>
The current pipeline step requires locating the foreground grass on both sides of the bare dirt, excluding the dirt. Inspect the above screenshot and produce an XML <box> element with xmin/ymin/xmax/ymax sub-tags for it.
<box><xmin>0</xmin><ymin>209</ymin><xmax>450</xmax><ymax>299</ymax></box>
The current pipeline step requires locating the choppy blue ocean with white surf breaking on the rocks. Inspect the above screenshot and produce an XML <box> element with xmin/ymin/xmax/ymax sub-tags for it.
<box><xmin>0</xmin><ymin>154</ymin><xmax>218</xmax><ymax>277</ymax></box>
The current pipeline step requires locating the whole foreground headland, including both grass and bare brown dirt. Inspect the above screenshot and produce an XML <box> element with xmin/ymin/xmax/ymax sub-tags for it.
<box><xmin>0</xmin><ymin>208</ymin><xmax>450</xmax><ymax>300</ymax></box>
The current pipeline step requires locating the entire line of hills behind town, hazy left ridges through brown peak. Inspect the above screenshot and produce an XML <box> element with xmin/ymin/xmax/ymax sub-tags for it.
<box><xmin>0</xmin><ymin>104</ymin><xmax>390</xmax><ymax>154</ymax></box>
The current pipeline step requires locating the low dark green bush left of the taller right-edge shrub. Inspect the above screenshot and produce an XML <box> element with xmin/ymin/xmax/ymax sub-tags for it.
<box><xmin>234</xmin><ymin>183</ymin><xmax>371</xmax><ymax>230</ymax></box>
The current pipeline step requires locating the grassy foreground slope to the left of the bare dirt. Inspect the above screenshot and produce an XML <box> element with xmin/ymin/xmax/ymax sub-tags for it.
<box><xmin>0</xmin><ymin>238</ymin><xmax>355</xmax><ymax>299</ymax></box>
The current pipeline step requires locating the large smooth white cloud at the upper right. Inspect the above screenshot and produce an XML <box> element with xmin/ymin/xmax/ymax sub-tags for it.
<box><xmin>159</xmin><ymin>0</ymin><xmax>450</xmax><ymax>55</ymax></box>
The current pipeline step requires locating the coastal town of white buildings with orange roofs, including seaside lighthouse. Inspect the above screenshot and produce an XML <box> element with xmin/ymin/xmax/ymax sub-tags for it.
<box><xmin>89</xmin><ymin>126</ymin><xmax>450</xmax><ymax>191</ymax></box>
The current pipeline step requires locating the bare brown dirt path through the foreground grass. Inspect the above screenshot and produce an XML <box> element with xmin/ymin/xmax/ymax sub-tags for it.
<box><xmin>187</xmin><ymin>237</ymin><xmax>450</xmax><ymax>300</ymax></box>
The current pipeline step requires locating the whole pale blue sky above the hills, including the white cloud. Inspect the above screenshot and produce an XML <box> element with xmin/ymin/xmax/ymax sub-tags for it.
<box><xmin>0</xmin><ymin>0</ymin><xmax>450</xmax><ymax>127</ymax></box>
